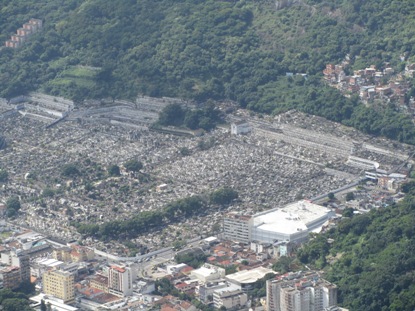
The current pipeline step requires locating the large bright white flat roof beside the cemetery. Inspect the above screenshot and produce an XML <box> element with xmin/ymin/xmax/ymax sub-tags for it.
<box><xmin>254</xmin><ymin>200</ymin><xmax>331</xmax><ymax>234</ymax></box>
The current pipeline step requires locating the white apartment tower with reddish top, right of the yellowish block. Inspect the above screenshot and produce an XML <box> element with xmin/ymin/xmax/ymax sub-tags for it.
<box><xmin>108</xmin><ymin>265</ymin><xmax>133</xmax><ymax>297</ymax></box>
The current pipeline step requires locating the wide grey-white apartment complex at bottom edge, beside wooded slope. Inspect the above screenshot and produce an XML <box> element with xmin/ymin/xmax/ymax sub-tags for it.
<box><xmin>266</xmin><ymin>273</ymin><xmax>337</xmax><ymax>311</ymax></box>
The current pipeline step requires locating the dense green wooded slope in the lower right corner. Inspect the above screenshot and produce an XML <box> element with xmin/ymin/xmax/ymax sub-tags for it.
<box><xmin>298</xmin><ymin>183</ymin><xmax>415</xmax><ymax>311</ymax></box>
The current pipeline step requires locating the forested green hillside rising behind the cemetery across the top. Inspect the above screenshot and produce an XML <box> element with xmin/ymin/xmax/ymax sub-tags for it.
<box><xmin>0</xmin><ymin>0</ymin><xmax>415</xmax><ymax>143</ymax></box>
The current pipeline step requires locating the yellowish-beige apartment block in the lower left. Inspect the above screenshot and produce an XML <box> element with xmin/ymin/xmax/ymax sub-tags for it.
<box><xmin>42</xmin><ymin>270</ymin><xmax>75</xmax><ymax>303</ymax></box>
